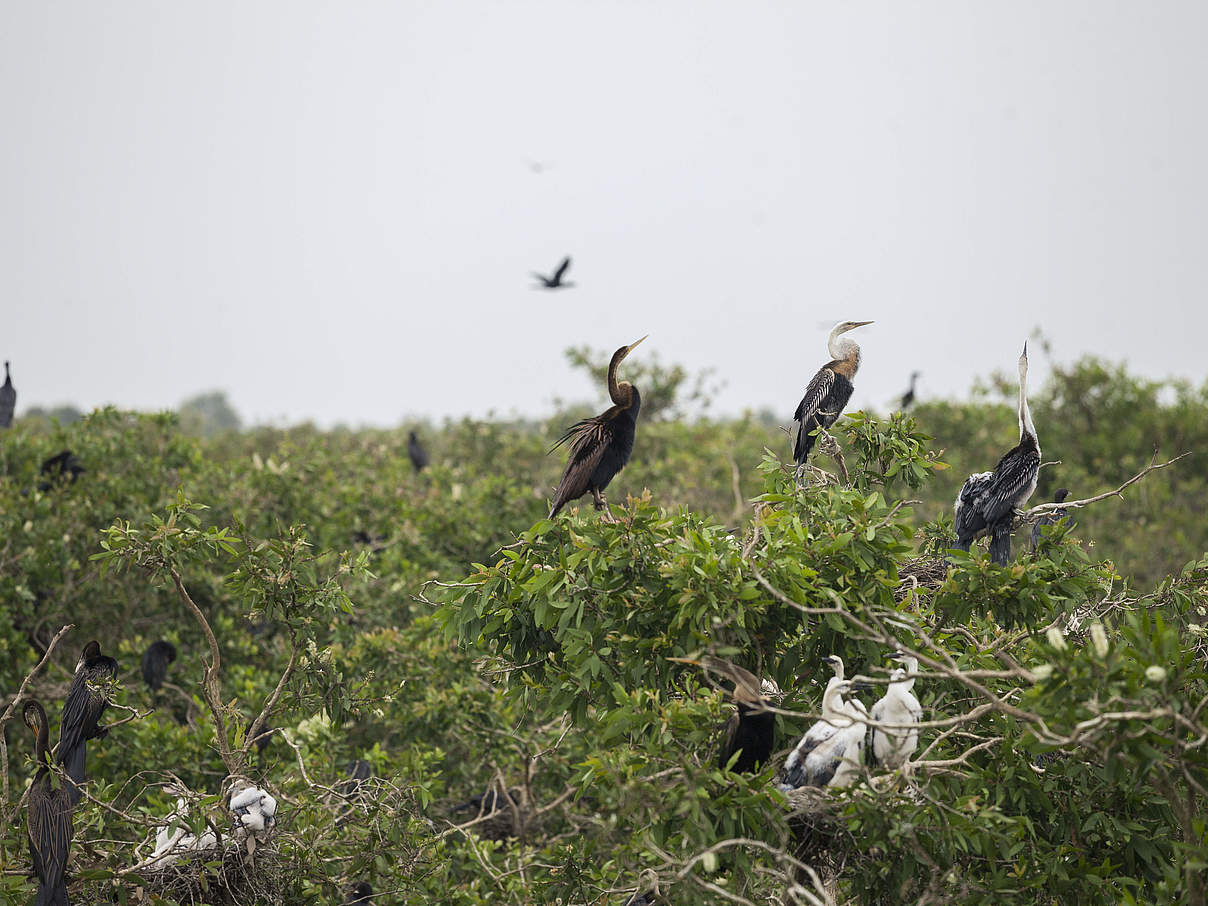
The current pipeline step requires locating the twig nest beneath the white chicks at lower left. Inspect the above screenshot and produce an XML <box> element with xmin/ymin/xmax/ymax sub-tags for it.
<box><xmin>133</xmin><ymin>847</ymin><xmax>288</xmax><ymax>906</ymax></box>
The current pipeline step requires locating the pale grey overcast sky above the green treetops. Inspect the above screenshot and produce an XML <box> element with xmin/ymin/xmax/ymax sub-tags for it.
<box><xmin>0</xmin><ymin>0</ymin><xmax>1208</xmax><ymax>425</ymax></box>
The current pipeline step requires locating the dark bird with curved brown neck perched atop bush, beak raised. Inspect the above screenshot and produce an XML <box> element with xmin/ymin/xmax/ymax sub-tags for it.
<box><xmin>550</xmin><ymin>335</ymin><xmax>649</xmax><ymax>522</ymax></box>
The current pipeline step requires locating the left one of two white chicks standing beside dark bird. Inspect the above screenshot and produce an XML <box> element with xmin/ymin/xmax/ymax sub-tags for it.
<box><xmin>779</xmin><ymin>676</ymin><xmax>865</xmax><ymax>792</ymax></box>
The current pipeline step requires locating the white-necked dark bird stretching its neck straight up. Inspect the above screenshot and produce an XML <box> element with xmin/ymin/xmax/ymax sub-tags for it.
<box><xmin>954</xmin><ymin>342</ymin><xmax>1040</xmax><ymax>567</ymax></box>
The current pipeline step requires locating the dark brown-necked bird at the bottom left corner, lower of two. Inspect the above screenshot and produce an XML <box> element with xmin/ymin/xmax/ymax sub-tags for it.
<box><xmin>22</xmin><ymin>699</ymin><xmax>75</xmax><ymax>906</ymax></box>
